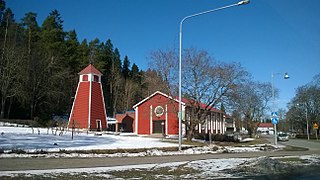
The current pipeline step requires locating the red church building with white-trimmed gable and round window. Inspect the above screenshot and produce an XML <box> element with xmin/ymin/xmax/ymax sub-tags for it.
<box><xmin>133</xmin><ymin>91</ymin><xmax>229</xmax><ymax>136</ymax></box>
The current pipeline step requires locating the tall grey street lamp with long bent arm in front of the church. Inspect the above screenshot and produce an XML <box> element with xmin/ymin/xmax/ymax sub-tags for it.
<box><xmin>178</xmin><ymin>0</ymin><xmax>250</xmax><ymax>151</ymax></box>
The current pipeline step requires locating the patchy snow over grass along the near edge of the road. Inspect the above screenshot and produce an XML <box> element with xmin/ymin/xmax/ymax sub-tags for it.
<box><xmin>0</xmin><ymin>155</ymin><xmax>320</xmax><ymax>179</ymax></box>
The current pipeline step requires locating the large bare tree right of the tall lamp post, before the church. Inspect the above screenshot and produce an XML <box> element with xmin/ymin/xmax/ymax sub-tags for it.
<box><xmin>182</xmin><ymin>48</ymin><xmax>249</xmax><ymax>140</ymax></box>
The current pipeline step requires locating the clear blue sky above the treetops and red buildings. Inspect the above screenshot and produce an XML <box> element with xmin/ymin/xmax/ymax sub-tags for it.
<box><xmin>7</xmin><ymin>0</ymin><xmax>320</xmax><ymax>108</ymax></box>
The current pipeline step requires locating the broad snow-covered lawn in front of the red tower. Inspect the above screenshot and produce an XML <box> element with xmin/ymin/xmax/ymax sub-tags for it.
<box><xmin>0</xmin><ymin>124</ymin><xmax>177</xmax><ymax>152</ymax></box>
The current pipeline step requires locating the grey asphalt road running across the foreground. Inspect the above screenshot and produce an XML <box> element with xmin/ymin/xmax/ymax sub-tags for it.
<box><xmin>0</xmin><ymin>150</ymin><xmax>320</xmax><ymax>174</ymax></box>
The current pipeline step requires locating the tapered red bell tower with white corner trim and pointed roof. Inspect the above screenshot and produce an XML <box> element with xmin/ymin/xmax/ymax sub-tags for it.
<box><xmin>68</xmin><ymin>64</ymin><xmax>107</xmax><ymax>131</ymax></box>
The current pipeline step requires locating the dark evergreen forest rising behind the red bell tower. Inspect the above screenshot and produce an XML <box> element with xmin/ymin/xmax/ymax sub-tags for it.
<box><xmin>0</xmin><ymin>5</ymin><xmax>156</xmax><ymax>121</ymax></box>
